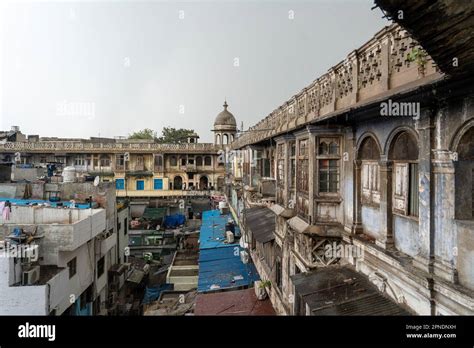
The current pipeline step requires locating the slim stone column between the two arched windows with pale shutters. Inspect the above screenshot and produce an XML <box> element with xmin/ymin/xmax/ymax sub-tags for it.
<box><xmin>375</xmin><ymin>156</ymin><xmax>394</xmax><ymax>249</ymax></box>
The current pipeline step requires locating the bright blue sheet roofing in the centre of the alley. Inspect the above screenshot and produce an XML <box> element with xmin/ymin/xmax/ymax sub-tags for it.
<box><xmin>198</xmin><ymin>210</ymin><xmax>260</xmax><ymax>292</ymax></box>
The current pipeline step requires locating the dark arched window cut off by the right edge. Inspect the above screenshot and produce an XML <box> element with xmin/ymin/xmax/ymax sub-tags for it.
<box><xmin>454</xmin><ymin>127</ymin><xmax>474</xmax><ymax>220</ymax></box>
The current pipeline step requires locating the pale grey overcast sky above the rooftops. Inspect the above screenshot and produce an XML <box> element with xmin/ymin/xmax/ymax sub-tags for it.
<box><xmin>0</xmin><ymin>0</ymin><xmax>390</xmax><ymax>142</ymax></box>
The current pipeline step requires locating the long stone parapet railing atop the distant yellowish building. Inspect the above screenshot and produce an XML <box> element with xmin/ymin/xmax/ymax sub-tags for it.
<box><xmin>0</xmin><ymin>141</ymin><xmax>220</xmax><ymax>153</ymax></box>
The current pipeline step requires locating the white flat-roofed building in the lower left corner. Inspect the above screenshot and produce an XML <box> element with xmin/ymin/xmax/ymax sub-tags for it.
<box><xmin>0</xmin><ymin>206</ymin><xmax>117</xmax><ymax>315</ymax></box>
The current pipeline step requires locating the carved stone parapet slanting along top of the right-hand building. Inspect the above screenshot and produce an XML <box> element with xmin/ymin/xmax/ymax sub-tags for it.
<box><xmin>232</xmin><ymin>24</ymin><xmax>442</xmax><ymax>149</ymax></box>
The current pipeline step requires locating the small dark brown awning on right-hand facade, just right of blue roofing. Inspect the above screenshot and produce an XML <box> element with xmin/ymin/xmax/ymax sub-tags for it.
<box><xmin>243</xmin><ymin>207</ymin><xmax>275</xmax><ymax>243</ymax></box>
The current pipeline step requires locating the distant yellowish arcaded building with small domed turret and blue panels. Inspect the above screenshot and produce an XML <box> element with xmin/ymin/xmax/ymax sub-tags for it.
<box><xmin>0</xmin><ymin>103</ymin><xmax>237</xmax><ymax>197</ymax></box>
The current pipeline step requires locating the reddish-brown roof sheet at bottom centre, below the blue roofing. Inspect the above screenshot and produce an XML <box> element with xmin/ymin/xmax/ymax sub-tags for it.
<box><xmin>194</xmin><ymin>288</ymin><xmax>275</xmax><ymax>315</ymax></box>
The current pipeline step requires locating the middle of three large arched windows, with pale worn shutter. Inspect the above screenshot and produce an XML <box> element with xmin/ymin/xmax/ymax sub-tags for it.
<box><xmin>389</xmin><ymin>131</ymin><xmax>419</xmax><ymax>216</ymax></box>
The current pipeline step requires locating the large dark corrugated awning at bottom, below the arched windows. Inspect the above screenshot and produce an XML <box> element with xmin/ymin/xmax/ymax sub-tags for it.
<box><xmin>291</xmin><ymin>265</ymin><xmax>411</xmax><ymax>315</ymax></box>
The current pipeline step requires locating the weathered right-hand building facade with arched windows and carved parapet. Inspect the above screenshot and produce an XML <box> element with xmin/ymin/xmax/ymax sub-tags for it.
<box><xmin>230</xmin><ymin>24</ymin><xmax>474</xmax><ymax>315</ymax></box>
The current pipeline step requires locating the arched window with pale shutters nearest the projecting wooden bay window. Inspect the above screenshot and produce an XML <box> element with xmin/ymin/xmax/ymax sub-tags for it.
<box><xmin>357</xmin><ymin>136</ymin><xmax>380</xmax><ymax>205</ymax></box>
